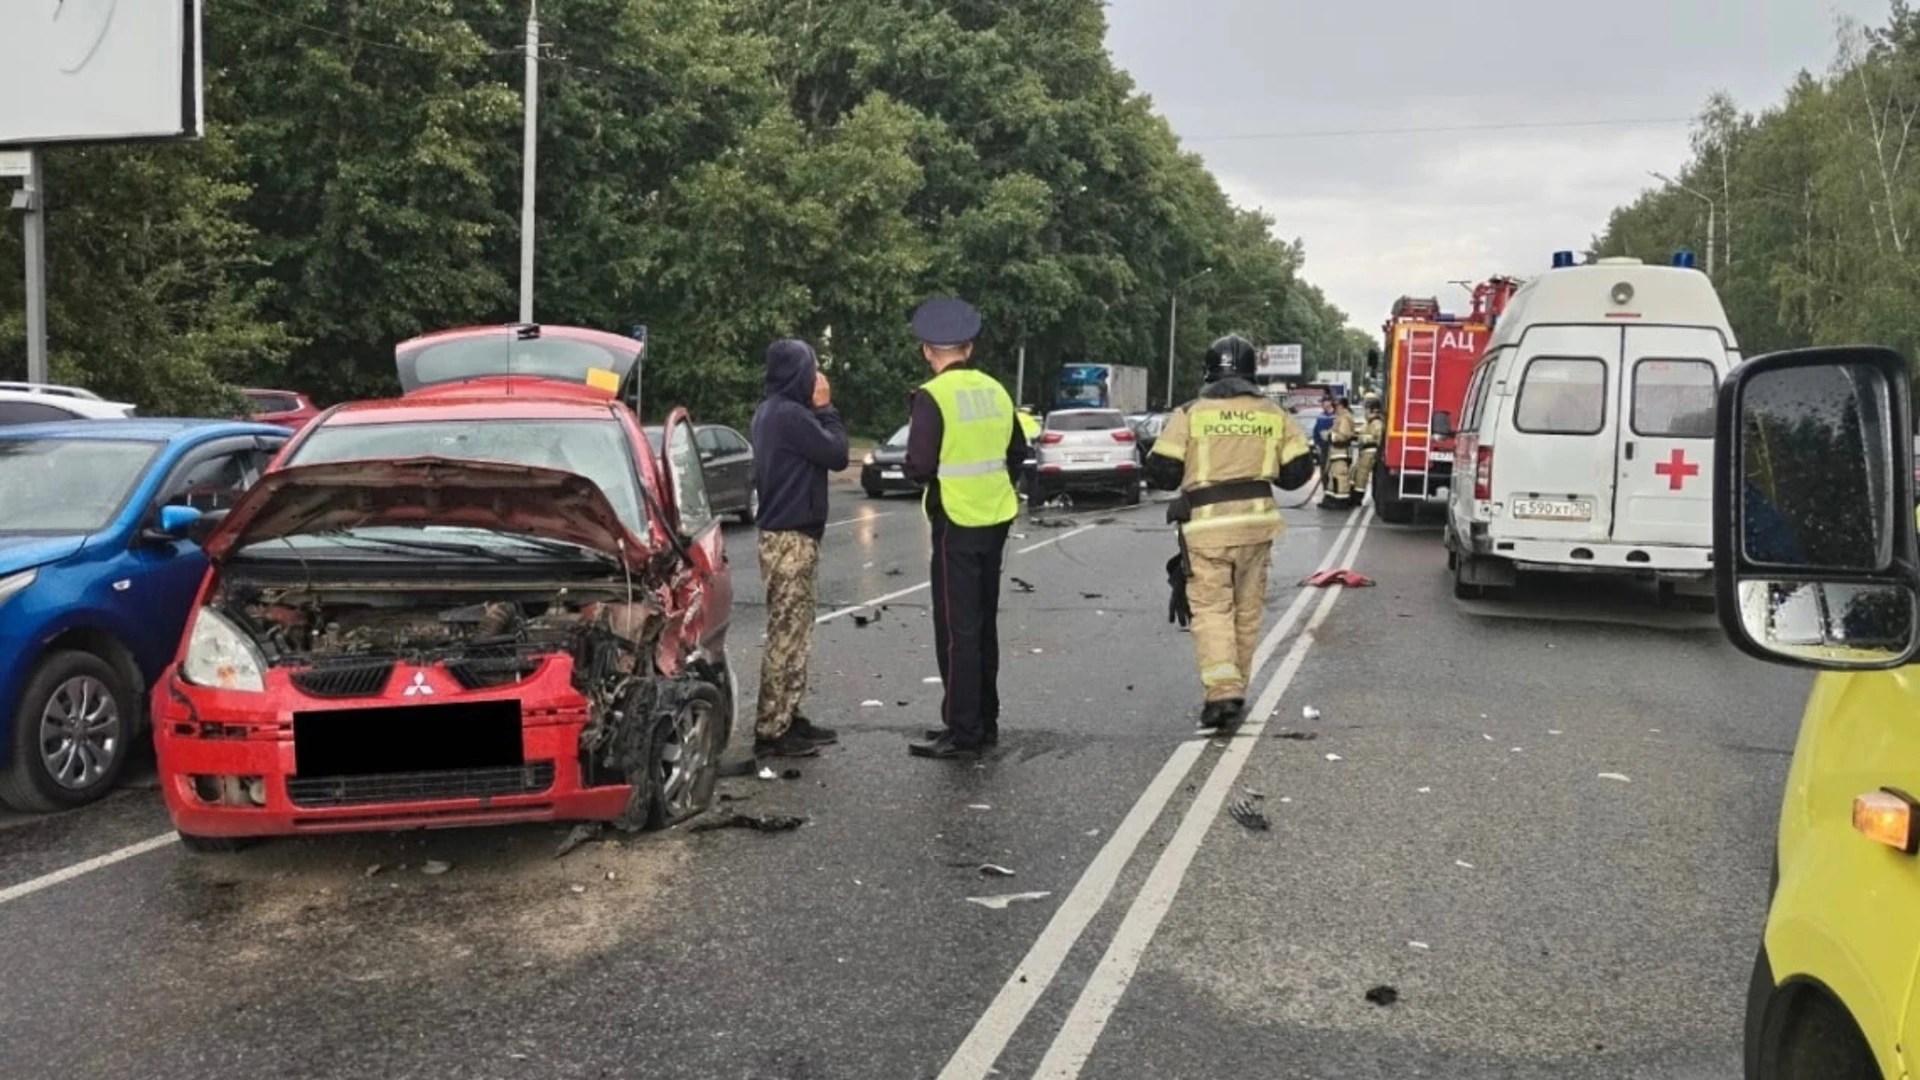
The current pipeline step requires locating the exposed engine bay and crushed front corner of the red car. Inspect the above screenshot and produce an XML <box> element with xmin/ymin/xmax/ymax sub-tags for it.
<box><xmin>211</xmin><ymin>578</ymin><xmax>732</xmax><ymax>828</ymax></box>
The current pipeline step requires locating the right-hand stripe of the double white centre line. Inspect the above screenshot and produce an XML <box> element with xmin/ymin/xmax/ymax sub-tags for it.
<box><xmin>1033</xmin><ymin>509</ymin><xmax>1373</xmax><ymax>1080</ymax></box>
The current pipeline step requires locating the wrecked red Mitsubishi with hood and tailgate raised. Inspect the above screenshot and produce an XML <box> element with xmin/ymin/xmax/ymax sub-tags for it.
<box><xmin>154</xmin><ymin>327</ymin><xmax>735</xmax><ymax>849</ymax></box>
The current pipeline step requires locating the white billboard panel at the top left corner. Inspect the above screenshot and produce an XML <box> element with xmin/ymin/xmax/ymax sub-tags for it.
<box><xmin>0</xmin><ymin>0</ymin><xmax>204</xmax><ymax>146</ymax></box>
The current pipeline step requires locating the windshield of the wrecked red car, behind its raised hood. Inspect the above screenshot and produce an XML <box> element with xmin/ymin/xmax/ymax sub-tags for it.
<box><xmin>288</xmin><ymin>417</ymin><xmax>647</xmax><ymax>534</ymax></box>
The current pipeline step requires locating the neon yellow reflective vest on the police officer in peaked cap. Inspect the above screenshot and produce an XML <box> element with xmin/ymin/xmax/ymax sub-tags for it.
<box><xmin>922</xmin><ymin>367</ymin><xmax>1020</xmax><ymax>528</ymax></box>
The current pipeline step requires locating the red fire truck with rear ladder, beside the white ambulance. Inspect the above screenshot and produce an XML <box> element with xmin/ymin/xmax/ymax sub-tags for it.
<box><xmin>1369</xmin><ymin>277</ymin><xmax>1521</xmax><ymax>525</ymax></box>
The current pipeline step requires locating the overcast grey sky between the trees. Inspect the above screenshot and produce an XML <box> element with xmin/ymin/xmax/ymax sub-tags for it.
<box><xmin>1108</xmin><ymin>0</ymin><xmax>1887</xmax><ymax>331</ymax></box>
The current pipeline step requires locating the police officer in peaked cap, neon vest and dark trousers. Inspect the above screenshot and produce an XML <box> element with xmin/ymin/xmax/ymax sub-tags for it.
<box><xmin>906</xmin><ymin>298</ymin><xmax>1027</xmax><ymax>759</ymax></box>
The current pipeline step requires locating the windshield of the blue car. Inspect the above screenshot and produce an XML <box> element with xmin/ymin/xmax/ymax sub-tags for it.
<box><xmin>0</xmin><ymin>438</ymin><xmax>159</xmax><ymax>534</ymax></box>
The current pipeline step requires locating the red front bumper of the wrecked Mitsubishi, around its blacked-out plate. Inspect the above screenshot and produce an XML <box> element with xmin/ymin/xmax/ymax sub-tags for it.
<box><xmin>152</xmin><ymin>657</ymin><xmax>632</xmax><ymax>836</ymax></box>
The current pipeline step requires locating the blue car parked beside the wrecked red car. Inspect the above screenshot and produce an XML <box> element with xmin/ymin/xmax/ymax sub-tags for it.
<box><xmin>0</xmin><ymin>419</ymin><xmax>290</xmax><ymax>811</ymax></box>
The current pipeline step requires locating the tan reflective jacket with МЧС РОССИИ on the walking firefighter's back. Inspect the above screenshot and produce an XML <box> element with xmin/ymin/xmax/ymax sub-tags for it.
<box><xmin>1154</xmin><ymin>388</ymin><xmax>1313</xmax><ymax>550</ymax></box>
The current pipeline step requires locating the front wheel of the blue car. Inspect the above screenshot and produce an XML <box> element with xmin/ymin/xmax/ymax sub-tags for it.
<box><xmin>0</xmin><ymin>651</ymin><xmax>140</xmax><ymax>813</ymax></box>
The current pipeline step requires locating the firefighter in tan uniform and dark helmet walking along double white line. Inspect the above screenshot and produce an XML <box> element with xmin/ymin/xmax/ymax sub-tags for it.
<box><xmin>1146</xmin><ymin>336</ymin><xmax>1313</xmax><ymax>728</ymax></box>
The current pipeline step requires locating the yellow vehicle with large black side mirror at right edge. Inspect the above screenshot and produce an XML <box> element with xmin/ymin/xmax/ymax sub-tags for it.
<box><xmin>1715</xmin><ymin>348</ymin><xmax>1920</xmax><ymax>1080</ymax></box>
